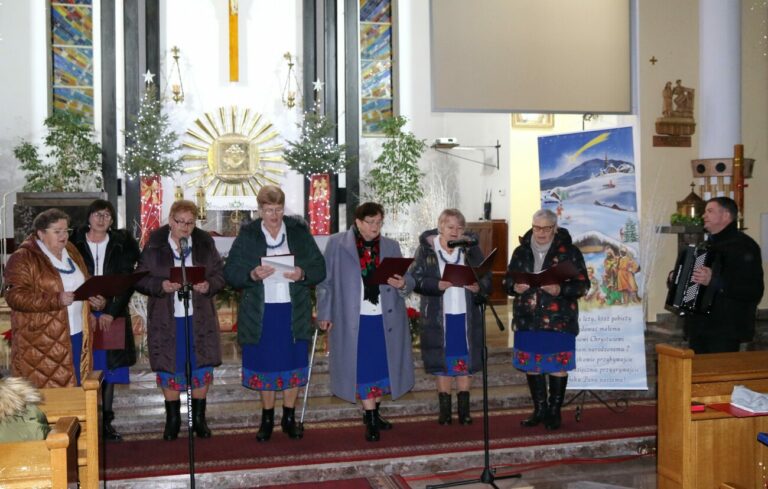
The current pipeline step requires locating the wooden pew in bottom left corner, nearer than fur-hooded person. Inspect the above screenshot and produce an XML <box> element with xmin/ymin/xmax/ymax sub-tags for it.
<box><xmin>0</xmin><ymin>417</ymin><xmax>79</xmax><ymax>489</ymax></box>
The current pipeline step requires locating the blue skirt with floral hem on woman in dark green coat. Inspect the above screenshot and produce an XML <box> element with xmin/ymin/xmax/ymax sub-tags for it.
<box><xmin>243</xmin><ymin>302</ymin><xmax>309</xmax><ymax>391</ymax></box>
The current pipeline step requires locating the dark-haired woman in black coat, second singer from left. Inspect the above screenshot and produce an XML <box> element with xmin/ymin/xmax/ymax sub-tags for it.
<box><xmin>71</xmin><ymin>199</ymin><xmax>139</xmax><ymax>440</ymax></box>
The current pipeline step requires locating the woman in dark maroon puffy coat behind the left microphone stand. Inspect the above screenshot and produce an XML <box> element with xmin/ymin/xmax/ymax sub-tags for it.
<box><xmin>136</xmin><ymin>200</ymin><xmax>224</xmax><ymax>440</ymax></box>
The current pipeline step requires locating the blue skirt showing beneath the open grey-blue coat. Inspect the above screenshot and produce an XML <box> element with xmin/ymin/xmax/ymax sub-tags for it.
<box><xmin>355</xmin><ymin>314</ymin><xmax>392</xmax><ymax>399</ymax></box>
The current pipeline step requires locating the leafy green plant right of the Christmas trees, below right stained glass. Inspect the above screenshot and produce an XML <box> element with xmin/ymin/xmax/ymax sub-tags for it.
<box><xmin>363</xmin><ymin>116</ymin><xmax>427</xmax><ymax>217</ymax></box>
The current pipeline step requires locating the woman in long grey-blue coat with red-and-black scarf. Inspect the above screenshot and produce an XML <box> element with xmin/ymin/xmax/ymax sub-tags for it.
<box><xmin>317</xmin><ymin>202</ymin><xmax>414</xmax><ymax>441</ymax></box>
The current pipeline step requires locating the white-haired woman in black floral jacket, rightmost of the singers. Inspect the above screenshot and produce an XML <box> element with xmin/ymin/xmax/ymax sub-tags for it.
<box><xmin>504</xmin><ymin>209</ymin><xmax>590</xmax><ymax>430</ymax></box>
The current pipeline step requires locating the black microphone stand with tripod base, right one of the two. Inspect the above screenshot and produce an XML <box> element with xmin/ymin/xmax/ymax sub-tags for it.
<box><xmin>427</xmin><ymin>248</ymin><xmax>522</xmax><ymax>489</ymax></box>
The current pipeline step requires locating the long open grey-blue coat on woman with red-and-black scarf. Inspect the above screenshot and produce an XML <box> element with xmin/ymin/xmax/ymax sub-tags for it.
<box><xmin>317</xmin><ymin>229</ymin><xmax>414</xmax><ymax>402</ymax></box>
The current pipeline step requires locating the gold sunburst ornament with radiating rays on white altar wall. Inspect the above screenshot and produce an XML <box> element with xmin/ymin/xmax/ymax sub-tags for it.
<box><xmin>182</xmin><ymin>106</ymin><xmax>285</xmax><ymax>196</ymax></box>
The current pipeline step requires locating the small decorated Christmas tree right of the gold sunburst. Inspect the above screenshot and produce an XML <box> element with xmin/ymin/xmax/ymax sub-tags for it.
<box><xmin>283</xmin><ymin>102</ymin><xmax>347</xmax><ymax>178</ymax></box>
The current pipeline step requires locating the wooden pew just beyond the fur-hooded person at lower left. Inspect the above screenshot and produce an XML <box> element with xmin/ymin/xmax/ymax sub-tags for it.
<box><xmin>40</xmin><ymin>370</ymin><xmax>102</xmax><ymax>489</ymax></box>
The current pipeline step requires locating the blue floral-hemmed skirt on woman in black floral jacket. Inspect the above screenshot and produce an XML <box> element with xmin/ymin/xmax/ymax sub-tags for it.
<box><xmin>512</xmin><ymin>331</ymin><xmax>576</xmax><ymax>374</ymax></box>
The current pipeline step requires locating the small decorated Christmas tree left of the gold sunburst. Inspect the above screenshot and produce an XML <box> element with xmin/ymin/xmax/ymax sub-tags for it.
<box><xmin>120</xmin><ymin>82</ymin><xmax>182</xmax><ymax>178</ymax></box>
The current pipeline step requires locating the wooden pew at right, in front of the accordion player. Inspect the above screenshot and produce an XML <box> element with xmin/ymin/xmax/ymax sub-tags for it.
<box><xmin>656</xmin><ymin>344</ymin><xmax>768</xmax><ymax>489</ymax></box>
